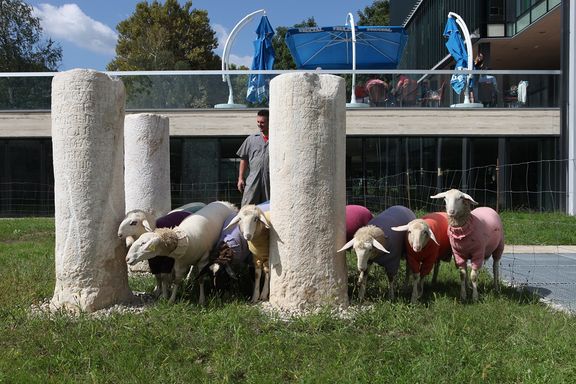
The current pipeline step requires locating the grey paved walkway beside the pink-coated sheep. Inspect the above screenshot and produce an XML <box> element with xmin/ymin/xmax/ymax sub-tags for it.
<box><xmin>486</xmin><ymin>245</ymin><xmax>576</xmax><ymax>313</ymax></box>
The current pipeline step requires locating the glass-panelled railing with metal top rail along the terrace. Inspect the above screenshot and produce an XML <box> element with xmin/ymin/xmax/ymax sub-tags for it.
<box><xmin>0</xmin><ymin>69</ymin><xmax>561</xmax><ymax>112</ymax></box>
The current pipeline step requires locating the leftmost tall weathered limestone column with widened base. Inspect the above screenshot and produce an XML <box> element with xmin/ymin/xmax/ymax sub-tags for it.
<box><xmin>51</xmin><ymin>69</ymin><xmax>133</xmax><ymax>312</ymax></box>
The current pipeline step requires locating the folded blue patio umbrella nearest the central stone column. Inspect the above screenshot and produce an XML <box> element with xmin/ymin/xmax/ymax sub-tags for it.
<box><xmin>246</xmin><ymin>15</ymin><xmax>275</xmax><ymax>103</ymax></box>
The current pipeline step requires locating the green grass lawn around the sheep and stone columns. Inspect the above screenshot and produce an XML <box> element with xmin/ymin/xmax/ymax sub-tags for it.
<box><xmin>0</xmin><ymin>218</ymin><xmax>576</xmax><ymax>383</ymax></box>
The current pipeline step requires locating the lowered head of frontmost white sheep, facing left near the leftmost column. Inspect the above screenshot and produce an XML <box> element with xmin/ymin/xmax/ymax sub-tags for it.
<box><xmin>126</xmin><ymin>228</ymin><xmax>178</xmax><ymax>265</ymax></box>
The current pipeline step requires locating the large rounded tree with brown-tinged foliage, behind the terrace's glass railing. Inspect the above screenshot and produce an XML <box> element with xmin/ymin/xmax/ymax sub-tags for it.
<box><xmin>107</xmin><ymin>0</ymin><xmax>225</xmax><ymax>108</ymax></box>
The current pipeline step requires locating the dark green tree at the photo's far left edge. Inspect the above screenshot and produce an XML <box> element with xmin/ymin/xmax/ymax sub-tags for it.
<box><xmin>0</xmin><ymin>0</ymin><xmax>62</xmax><ymax>109</ymax></box>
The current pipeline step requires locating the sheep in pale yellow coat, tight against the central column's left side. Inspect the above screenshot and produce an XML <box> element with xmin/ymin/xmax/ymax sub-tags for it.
<box><xmin>225</xmin><ymin>204</ymin><xmax>270</xmax><ymax>303</ymax></box>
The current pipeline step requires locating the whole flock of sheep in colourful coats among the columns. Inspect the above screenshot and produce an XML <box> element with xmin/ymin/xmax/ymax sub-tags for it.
<box><xmin>118</xmin><ymin>189</ymin><xmax>504</xmax><ymax>304</ymax></box>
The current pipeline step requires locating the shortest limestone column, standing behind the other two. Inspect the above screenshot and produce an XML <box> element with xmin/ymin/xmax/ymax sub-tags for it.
<box><xmin>124</xmin><ymin>113</ymin><xmax>172</xmax><ymax>218</ymax></box>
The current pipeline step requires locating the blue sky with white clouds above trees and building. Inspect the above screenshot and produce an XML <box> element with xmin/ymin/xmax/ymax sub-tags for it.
<box><xmin>25</xmin><ymin>0</ymin><xmax>373</xmax><ymax>71</ymax></box>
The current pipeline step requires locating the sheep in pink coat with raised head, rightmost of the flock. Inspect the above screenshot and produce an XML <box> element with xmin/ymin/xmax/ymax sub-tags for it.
<box><xmin>430</xmin><ymin>189</ymin><xmax>504</xmax><ymax>301</ymax></box>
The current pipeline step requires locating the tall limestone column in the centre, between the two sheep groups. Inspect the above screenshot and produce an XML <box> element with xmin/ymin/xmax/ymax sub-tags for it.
<box><xmin>269</xmin><ymin>73</ymin><xmax>348</xmax><ymax>311</ymax></box>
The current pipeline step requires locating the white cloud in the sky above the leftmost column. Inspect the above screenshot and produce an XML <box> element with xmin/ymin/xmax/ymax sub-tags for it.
<box><xmin>34</xmin><ymin>4</ymin><xmax>118</xmax><ymax>55</ymax></box>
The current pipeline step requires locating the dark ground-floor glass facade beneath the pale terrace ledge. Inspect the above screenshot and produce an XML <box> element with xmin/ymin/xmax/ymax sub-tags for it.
<box><xmin>0</xmin><ymin>136</ymin><xmax>565</xmax><ymax>217</ymax></box>
